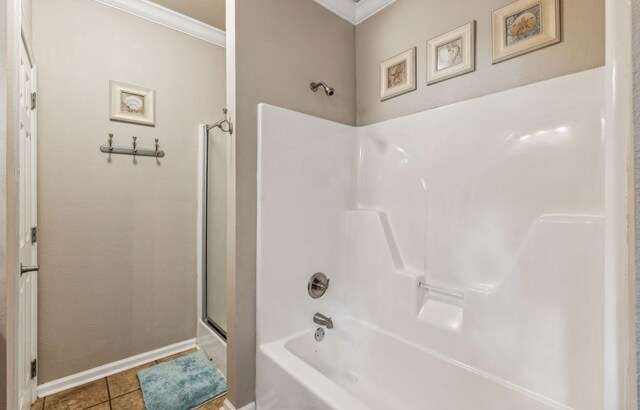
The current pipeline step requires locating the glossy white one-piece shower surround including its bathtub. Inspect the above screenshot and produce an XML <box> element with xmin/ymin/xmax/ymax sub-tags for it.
<box><xmin>256</xmin><ymin>69</ymin><xmax>605</xmax><ymax>410</ymax></box>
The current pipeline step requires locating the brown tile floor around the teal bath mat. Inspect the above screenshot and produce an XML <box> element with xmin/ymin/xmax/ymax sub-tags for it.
<box><xmin>31</xmin><ymin>349</ymin><xmax>225</xmax><ymax>410</ymax></box>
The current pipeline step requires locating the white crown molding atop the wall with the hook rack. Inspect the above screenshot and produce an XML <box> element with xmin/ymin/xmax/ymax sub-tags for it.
<box><xmin>95</xmin><ymin>0</ymin><xmax>227</xmax><ymax>47</ymax></box>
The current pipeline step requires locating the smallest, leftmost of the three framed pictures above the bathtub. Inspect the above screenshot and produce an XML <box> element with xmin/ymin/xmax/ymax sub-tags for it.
<box><xmin>380</xmin><ymin>47</ymin><xmax>416</xmax><ymax>101</ymax></box>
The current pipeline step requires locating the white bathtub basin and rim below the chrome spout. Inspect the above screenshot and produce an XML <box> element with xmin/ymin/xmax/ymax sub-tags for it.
<box><xmin>258</xmin><ymin>318</ymin><xmax>569</xmax><ymax>410</ymax></box>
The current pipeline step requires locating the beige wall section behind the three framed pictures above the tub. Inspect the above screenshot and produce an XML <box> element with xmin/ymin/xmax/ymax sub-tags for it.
<box><xmin>356</xmin><ymin>0</ymin><xmax>604</xmax><ymax>125</ymax></box>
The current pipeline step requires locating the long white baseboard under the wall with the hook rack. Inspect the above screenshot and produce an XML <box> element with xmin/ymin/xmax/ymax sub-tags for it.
<box><xmin>38</xmin><ymin>339</ymin><xmax>196</xmax><ymax>397</ymax></box>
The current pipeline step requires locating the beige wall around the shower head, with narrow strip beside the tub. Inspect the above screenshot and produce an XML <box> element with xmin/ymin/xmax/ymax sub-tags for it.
<box><xmin>227</xmin><ymin>0</ymin><xmax>356</xmax><ymax>407</ymax></box>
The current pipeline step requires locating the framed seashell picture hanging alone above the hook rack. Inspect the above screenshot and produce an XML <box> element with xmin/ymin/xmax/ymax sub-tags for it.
<box><xmin>110</xmin><ymin>81</ymin><xmax>156</xmax><ymax>126</ymax></box>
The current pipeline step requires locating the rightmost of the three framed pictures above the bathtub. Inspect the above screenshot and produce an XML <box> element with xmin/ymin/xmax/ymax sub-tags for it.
<box><xmin>491</xmin><ymin>0</ymin><xmax>560</xmax><ymax>64</ymax></box>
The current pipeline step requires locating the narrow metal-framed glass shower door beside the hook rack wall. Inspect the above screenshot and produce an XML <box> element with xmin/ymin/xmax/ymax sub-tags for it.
<box><xmin>202</xmin><ymin>129</ymin><xmax>230</xmax><ymax>340</ymax></box>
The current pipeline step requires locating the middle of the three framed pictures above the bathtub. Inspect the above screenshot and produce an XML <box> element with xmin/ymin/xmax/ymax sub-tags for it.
<box><xmin>427</xmin><ymin>21</ymin><xmax>476</xmax><ymax>85</ymax></box>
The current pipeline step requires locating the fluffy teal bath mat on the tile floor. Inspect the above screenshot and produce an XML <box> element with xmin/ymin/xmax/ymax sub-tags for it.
<box><xmin>138</xmin><ymin>351</ymin><xmax>227</xmax><ymax>410</ymax></box>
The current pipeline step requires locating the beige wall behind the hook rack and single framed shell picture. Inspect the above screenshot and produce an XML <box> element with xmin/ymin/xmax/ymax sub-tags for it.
<box><xmin>33</xmin><ymin>0</ymin><xmax>225</xmax><ymax>383</ymax></box>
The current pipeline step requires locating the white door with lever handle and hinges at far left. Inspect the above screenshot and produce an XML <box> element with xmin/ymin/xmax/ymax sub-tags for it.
<box><xmin>16</xmin><ymin>36</ymin><xmax>38</xmax><ymax>410</ymax></box>
